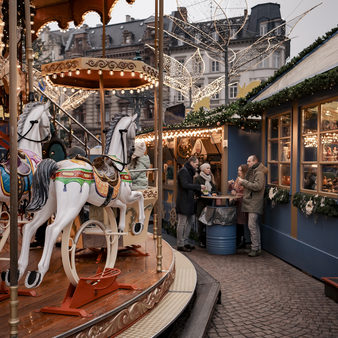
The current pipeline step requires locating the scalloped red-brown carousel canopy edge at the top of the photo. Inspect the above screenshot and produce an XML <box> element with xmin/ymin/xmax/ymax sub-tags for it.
<box><xmin>31</xmin><ymin>0</ymin><xmax>135</xmax><ymax>37</ymax></box>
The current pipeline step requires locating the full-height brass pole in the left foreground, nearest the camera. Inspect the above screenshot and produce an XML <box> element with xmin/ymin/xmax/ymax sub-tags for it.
<box><xmin>8</xmin><ymin>0</ymin><xmax>19</xmax><ymax>337</ymax></box>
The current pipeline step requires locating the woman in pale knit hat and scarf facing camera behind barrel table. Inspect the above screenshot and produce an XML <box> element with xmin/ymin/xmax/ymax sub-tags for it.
<box><xmin>194</xmin><ymin>162</ymin><xmax>217</xmax><ymax>248</ymax></box>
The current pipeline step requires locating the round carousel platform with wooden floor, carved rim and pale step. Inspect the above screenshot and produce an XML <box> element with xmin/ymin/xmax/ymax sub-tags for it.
<box><xmin>0</xmin><ymin>234</ymin><xmax>197</xmax><ymax>337</ymax></box>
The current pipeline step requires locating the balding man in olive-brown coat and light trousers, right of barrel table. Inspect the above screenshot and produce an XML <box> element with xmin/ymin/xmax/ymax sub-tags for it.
<box><xmin>238</xmin><ymin>155</ymin><xmax>266</xmax><ymax>257</ymax></box>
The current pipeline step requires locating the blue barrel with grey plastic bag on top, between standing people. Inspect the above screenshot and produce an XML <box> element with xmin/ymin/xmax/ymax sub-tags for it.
<box><xmin>202</xmin><ymin>206</ymin><xmax>236</xmax><ymax>255</ymax></box>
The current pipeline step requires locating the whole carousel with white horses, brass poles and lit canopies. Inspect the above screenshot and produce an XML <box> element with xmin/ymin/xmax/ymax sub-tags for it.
<box><xmin>0</xmin><ymin>0</ymin><xmax>197</xmax><ymax>337</ymax></box>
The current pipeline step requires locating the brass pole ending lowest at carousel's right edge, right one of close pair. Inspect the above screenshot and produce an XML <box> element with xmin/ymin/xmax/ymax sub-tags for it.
<box><xmin>157</xmin><ymin>0</ymin><xmax>163</xmax><ymax>272</ymax></box>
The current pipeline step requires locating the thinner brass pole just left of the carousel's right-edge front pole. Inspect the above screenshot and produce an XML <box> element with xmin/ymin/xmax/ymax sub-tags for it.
<box><xmin>153</xmin><ymin>0</ymin><xmax>158</xmax><ymax>239</ymax></box>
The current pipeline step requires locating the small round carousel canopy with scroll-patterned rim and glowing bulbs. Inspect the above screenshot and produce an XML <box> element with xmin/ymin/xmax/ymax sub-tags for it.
<box><xmin>41</xmin><ymin>57</ymin><xmax>158</xmax><ymax>91</ymax></box>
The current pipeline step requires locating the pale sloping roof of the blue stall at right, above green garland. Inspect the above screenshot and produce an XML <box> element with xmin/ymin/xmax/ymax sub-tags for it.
<box><xmin>253</xmin><ymin>32</ymin><xmax>338</xmax><ymax>102</ymax></box>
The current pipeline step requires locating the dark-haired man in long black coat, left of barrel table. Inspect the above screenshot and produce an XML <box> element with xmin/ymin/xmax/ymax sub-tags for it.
<box><xmin>176</xmin><ymin>156</ymin><xmax>205</xmax><ymax>252</ymax></box>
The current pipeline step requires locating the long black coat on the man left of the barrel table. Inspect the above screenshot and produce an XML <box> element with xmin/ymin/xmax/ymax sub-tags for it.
<box><xmin>176</xmin><ymin>162</ymin><xmax>201</xmax><ymax>216</ymax></box>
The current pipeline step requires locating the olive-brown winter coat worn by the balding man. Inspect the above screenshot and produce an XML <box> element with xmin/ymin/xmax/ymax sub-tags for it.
<box><xmin>241</xmin><ymin>163</ymin><xmax>266</xmax><ymax>214</ymax></box>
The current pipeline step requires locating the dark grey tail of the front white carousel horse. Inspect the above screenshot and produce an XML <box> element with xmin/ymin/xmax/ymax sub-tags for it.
<box><xmin>26</xmin><ymin>158</ymin><xmax>58</xmax><ymax>212</ymax></box>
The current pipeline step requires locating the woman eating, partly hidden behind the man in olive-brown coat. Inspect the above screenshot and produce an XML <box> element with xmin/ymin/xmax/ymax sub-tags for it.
<box><xmin>228</xmin><ymin>164</ymin><xmax>248</xmax><ymax>249</ymax></box>
